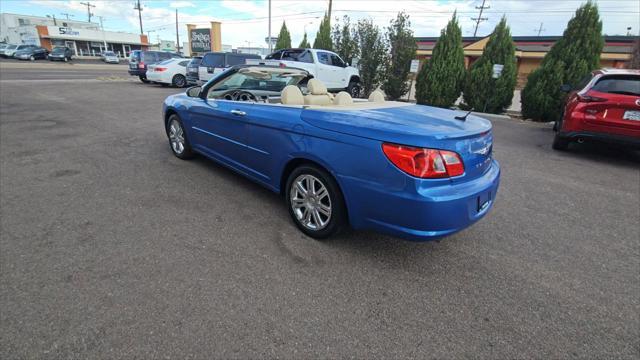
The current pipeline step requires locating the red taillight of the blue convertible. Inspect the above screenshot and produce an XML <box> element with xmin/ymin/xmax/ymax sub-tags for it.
<box><xmin>382</xmin><ymin>144</ymin><xmax>464</xmax><ymax>179</ymax></box>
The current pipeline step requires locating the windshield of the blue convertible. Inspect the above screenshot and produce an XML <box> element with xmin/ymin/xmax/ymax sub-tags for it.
<box><xmin>209</xmin><ymin>67</ymin><xmax>307</xmax><ymax>97</ymax></box>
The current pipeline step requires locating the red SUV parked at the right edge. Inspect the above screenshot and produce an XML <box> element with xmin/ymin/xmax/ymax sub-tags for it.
<box><xmin>553</xmin><ymin>69</ymin><xmax>640</xmax><ymax>150</ymax></box>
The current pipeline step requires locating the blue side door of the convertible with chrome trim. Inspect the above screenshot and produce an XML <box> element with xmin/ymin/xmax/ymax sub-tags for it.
<box><xmin>190</xmin><ymin>92</ymin><xmax>252</xmax><ymax>168</ymax></box>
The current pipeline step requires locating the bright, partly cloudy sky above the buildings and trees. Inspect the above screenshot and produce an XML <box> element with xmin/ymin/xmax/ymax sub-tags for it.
<box><xmin>0</xmin><ymin>0</ymin><xmax>640</xmax><ymax>48</ymax></box>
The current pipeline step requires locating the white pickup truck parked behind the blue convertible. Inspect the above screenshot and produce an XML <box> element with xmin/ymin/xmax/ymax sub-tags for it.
<box><xmin>265</xmin><ymin>49</ymin><xmax>361</xmax><ymax>98</ymax></box>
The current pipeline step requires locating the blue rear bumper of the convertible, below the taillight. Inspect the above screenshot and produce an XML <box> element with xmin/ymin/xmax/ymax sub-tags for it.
<box><xmin>342</xmin><ymin>160</ymin><xmax>500</xmax><ymax>241</ymax></box>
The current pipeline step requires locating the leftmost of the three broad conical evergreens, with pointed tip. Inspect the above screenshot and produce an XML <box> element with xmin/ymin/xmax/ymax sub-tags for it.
<box><xmin>416</xmin><ymin>12</ymin><xmax>465</xmax><ymax>107</ymax></box>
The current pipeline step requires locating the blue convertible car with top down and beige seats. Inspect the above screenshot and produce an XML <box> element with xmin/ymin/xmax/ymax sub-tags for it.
<box><xmin>163</xmin><ymin>65</ymin><xmax>500</xmax><ymax>240</ymax></box>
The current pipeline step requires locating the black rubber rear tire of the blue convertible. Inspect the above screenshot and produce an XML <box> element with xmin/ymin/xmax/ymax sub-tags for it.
<box><xmin>285</xmin><ymin>165</ymin><xmax>347</xmax><ymax>240</ymax></box>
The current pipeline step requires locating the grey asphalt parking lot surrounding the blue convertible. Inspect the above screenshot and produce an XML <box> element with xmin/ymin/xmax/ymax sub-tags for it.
<box><xmin>0</xmin><ymin>62</ymin><xmax>640</xmax><ymax>359</ymax></box>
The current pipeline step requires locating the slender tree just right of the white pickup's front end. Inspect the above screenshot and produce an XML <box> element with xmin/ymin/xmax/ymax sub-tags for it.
<box><xmin>356</xmin><ymin>19</ymin><xmax>387</xmax><ymax>97</ymax></box>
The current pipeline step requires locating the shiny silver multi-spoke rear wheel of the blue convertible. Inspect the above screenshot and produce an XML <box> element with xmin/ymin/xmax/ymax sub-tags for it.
<box><xmin>290</xmin><ymin>174</ymin><xmax>332</xmax><ymax>231</ymax></box>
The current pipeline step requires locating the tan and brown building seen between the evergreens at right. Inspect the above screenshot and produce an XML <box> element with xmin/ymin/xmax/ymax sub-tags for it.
<box><xmin>416</xmin><ymin>36</ymin><xmax>638</xmax><ymax>87</ymax></box>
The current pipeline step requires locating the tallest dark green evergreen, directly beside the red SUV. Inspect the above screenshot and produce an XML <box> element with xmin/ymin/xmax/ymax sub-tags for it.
<box><xmin>521</xmin><ymin>1</ymin><xmax>604</xmax><ymax>121</ymax></box>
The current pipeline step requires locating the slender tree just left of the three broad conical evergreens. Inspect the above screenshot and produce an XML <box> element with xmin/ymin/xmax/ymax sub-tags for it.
<box><xmin>382</xmin><ymin>12</ymin><xmax>417</xmax><ymax>100</ymax></box>
